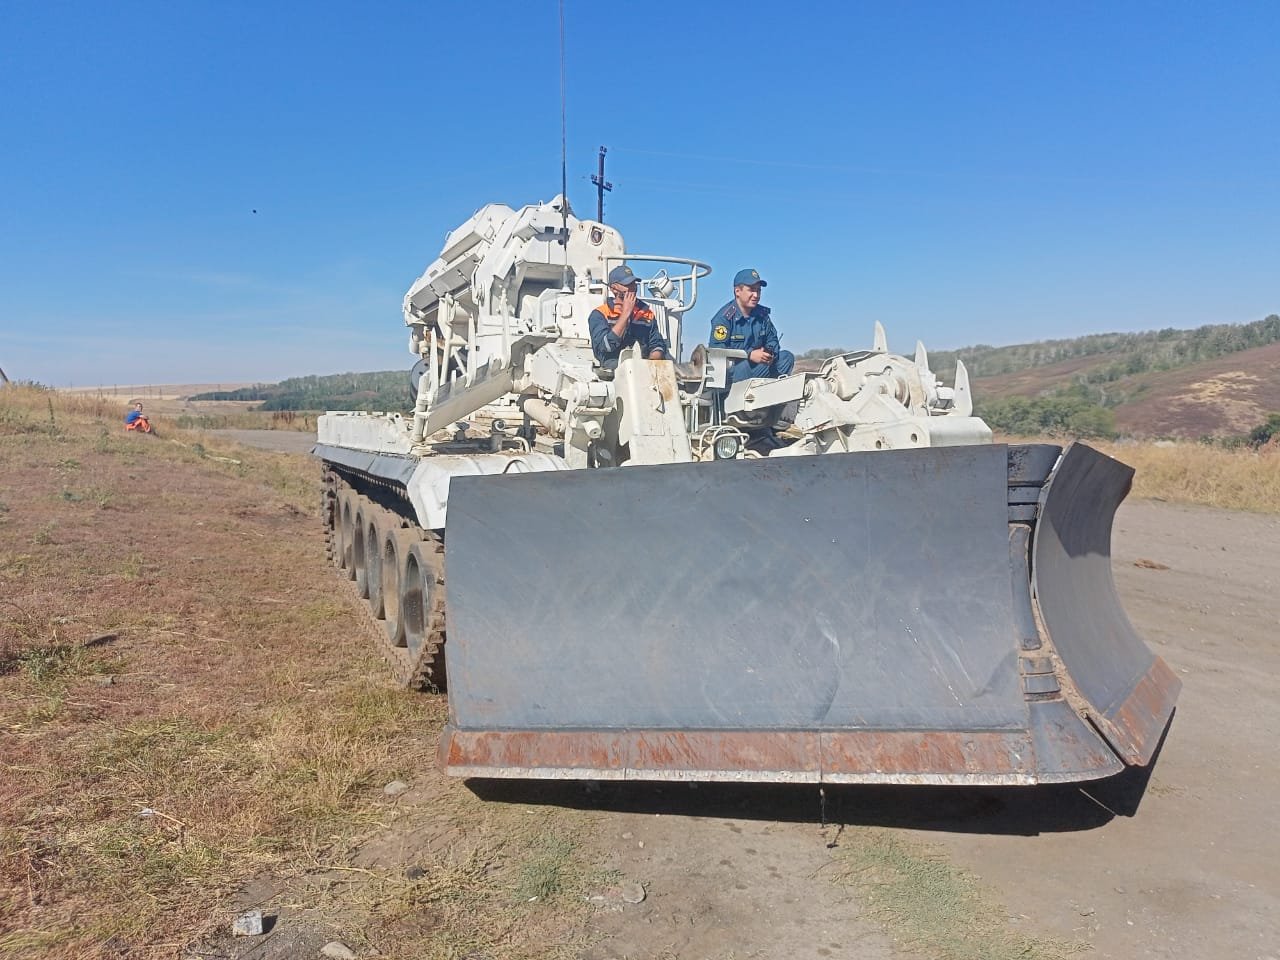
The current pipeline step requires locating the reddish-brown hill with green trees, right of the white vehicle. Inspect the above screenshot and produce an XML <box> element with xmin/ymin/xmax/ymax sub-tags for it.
<box><xmin>801</xmin><ymin>314</ymin><xmax>1280</xmax><ymax>438</ymax></box>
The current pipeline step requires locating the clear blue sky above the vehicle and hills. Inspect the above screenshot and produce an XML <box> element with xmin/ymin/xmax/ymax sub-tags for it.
<box><xmin>0</xmin><ymin>0</ymin><xmax>1280</xmax><ymax>385</ymax></box>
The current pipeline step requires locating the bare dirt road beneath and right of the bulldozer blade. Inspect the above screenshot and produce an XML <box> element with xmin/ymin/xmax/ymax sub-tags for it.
<box><xmin>225</xmin><ymin>430</ymin><xmax>1280</xmax><ymax>960</ymax></box>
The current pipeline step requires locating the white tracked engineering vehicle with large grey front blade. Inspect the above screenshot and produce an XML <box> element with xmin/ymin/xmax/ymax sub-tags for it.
<box><xmin>315</xmin><ymin>200</ymin><xmax>1179</xmax><ymax>783</ymax></box>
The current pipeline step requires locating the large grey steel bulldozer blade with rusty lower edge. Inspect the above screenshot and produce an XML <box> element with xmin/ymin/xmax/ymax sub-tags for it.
<box><xmin>440</xmin><ymin>444</ymin><xmax>1171</xmax><ymax>783</ymax></box>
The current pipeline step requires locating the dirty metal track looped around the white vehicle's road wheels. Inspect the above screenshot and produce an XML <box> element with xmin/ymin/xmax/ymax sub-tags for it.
<box><xmin>320</xmin><ymin>465</ymin><xmax>445</xmax><ymax>690</ymax></box>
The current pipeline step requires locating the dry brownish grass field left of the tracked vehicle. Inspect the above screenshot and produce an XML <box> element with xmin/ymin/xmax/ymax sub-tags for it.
<box><xmin>0</xmin><ymin>388</ymin><xmax>588</xmax><ymax>959</ymax></box>
